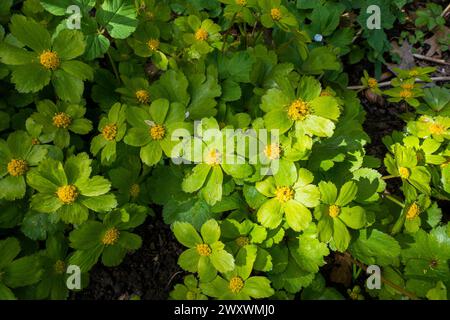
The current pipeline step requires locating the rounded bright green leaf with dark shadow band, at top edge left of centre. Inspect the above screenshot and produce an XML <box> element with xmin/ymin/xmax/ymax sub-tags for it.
<box><xmin>96</xmin><ymin>0</ymin><xmax>138</xmax><ymax>39</ymax></box>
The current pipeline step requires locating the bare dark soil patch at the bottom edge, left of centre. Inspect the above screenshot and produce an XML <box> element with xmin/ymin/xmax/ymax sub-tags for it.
<box><xmin>73</xmin><ymin>217</ymin><xmax>183</xmax><ymax>300</ymax></box>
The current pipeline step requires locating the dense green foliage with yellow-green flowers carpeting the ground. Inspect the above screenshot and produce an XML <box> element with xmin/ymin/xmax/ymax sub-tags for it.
<box><xmin>0</xmin><ymin>0</ymin><xmax>450</xmax><ymax>299</ymax></box>
